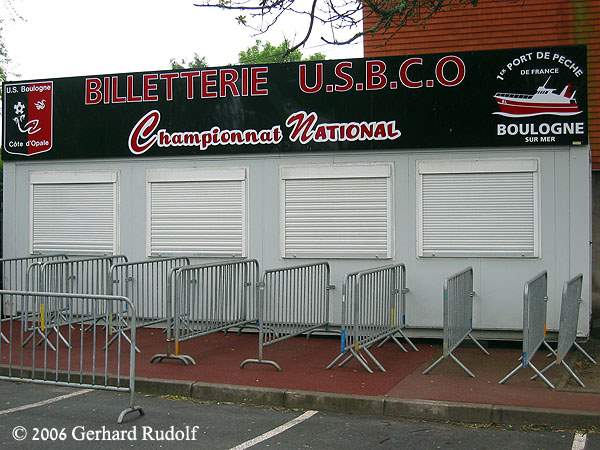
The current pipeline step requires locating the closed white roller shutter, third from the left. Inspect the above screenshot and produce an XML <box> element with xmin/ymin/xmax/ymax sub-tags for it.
<box><xmin>281</xmin><ymin>164</ymin><xmax>392</xmax><ymax>258</ymax></box>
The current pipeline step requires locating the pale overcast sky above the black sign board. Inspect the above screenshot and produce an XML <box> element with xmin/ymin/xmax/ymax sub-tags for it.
<box><xmin>0</xmin><ymin>0</ymin><xmax>362</xmax><ymax>80</ymax></box>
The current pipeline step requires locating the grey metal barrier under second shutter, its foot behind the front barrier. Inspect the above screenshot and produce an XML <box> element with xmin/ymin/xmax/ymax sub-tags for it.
<box><xmin>108</xmin><ymin>257</ymin><xmax>190</xmax><ymax>352</ymax></box>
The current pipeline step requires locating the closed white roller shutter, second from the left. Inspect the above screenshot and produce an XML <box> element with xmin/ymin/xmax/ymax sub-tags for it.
<box><xmin>148</xmin><ymin>169</ymin><xmax>246</xmax><ymax>257</ymax></box>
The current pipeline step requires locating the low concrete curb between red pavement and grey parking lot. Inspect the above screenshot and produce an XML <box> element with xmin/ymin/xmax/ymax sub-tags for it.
<box><xmin>136</xmin><ymin>378</ymin><xmax>600</xmax><ymax>428</ymax></box>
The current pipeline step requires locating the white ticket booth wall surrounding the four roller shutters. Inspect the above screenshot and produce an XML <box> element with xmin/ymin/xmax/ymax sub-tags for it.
<box><xmin>3</xmin><ymin>146</ymin><xmax>591</xmax><ymax>338</ymax></box>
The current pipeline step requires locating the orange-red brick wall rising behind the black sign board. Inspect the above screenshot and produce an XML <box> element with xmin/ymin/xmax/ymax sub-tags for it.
<box><xmin>364</xmin><ymin>0</ymin><xmax>600</xmax><ymax>170</ymax></box>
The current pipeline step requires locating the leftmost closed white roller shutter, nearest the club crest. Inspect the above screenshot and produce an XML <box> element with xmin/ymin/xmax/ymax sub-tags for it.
<box><xmin>31</xmin><ymin>172</ymin><xmax>118</xmax><ymax>255</ymax></box>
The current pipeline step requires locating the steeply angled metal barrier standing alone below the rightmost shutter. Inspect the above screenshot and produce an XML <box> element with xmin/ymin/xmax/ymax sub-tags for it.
<box><xmin>423</xmin><ymin>267</ymin><xmax>489</xmax><ymax>378</ymax></box>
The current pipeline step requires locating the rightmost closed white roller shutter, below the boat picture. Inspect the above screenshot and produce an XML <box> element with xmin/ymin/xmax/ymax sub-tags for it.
<box><xmin>417</xmin><ymin>160</ymin><xmax>538</xmax><ymax>257</ymax></box>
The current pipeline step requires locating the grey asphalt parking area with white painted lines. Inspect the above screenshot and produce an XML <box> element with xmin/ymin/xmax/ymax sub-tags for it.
<box><xmin>0</xmin><ymin>381</ymin><xmax>600</xmax><ymax>450</ymax></box>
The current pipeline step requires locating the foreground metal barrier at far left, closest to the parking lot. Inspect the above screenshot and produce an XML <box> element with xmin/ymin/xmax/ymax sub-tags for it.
<box><xmin>0</xmin><ymin>290</ymin><xmax>144</xmax><ymax>423</ymax></box>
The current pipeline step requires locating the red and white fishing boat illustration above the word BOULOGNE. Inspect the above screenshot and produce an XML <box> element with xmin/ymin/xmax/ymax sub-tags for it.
<box><xmin>494</xmin><ymin>77</ymin><xmax>581</xmax><ymax>117</ymax></box>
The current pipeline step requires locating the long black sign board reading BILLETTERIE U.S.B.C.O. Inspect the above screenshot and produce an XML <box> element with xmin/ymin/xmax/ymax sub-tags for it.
<box><xmin>3</xmin><ymin>46</ymin><xmax>588</xmax><ymax>160</ymax></box>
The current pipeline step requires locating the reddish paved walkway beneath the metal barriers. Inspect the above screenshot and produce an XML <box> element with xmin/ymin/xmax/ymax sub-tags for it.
<box><xmin>0</xmin><ymin>322</ymin><xmax>600</xmax><ymax>413</ymax></box>
